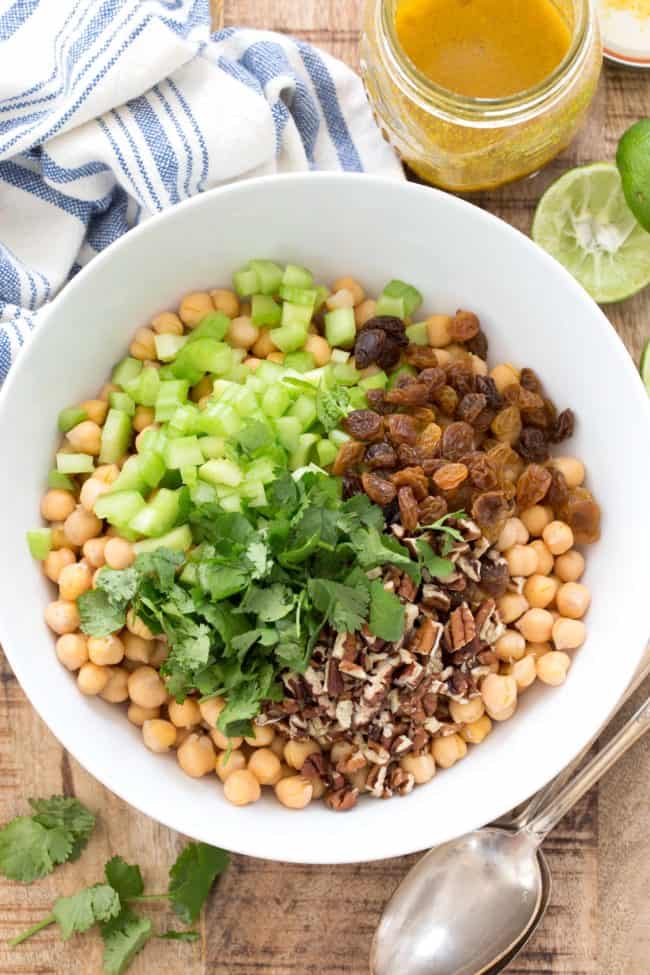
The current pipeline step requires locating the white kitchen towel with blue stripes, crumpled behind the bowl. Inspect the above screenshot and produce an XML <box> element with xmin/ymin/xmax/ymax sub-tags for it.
<box><xmin>0</xmin><ymin>0</ymin><xmax>402</xmax><ymax>382</ymax></box>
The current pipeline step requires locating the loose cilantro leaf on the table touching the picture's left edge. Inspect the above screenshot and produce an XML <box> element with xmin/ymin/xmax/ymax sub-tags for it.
<box><xmin>0</xmin><ymin>796</ymin><xmax>95</xmax><ymax>883</ymax></box>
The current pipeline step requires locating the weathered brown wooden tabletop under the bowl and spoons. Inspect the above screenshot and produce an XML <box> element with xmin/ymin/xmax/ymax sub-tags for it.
<box><xmin>0</xmin><ymin>0</ymin><xmax>650</xmax><ymax>975</ymax></box>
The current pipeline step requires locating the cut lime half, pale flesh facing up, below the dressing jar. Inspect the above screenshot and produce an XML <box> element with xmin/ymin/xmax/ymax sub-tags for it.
<box><xmin>532</xmin><ymin>163</ymin><xmax>650</xmax><ymax>303</ymax></box>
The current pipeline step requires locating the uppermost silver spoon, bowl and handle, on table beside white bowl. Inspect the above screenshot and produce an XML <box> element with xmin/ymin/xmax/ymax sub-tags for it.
<box><xmin>370</xmin><ymin>697</ymin><xmax>650</xmax><ymax>975</ymax></box>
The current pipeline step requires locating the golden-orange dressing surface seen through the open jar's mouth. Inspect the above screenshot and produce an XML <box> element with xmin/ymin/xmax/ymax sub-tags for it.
<box><xmin>395</xmin><ymin>0</ymin><xmax>571</xmax><ymax>98</ymax></box>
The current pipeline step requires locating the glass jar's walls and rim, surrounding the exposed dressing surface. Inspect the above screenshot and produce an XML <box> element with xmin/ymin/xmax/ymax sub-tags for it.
<box><xmin>361</xmin><ymin>0</ymin><xmax>602</xmax><ymax>192</ymax></box>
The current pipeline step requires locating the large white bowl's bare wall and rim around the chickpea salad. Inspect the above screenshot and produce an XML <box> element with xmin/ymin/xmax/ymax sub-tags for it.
<box><xmin>0</xmin><ymin>174</ymin><xmax>650</xmax><ymax>863</ymax></box>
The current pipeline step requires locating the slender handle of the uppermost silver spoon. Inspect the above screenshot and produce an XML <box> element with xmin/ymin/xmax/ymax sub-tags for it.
<box><xmin>521</xmin><ymin>697</ymin><xmax>650</xmax><ymax>844</ymax></box>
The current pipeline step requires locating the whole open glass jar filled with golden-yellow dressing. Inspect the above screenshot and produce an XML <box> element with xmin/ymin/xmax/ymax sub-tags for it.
<box><xmin>361</xmin><ymin>0</ymin><xmax>602</xmax><ymax>192</ymax></box>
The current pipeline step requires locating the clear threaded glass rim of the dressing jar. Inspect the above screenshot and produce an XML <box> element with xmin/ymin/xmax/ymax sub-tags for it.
<box><xmin>377</xmin><ymin>0</ymin><xmax>595</xmax><ymax>125</ymax></box>
